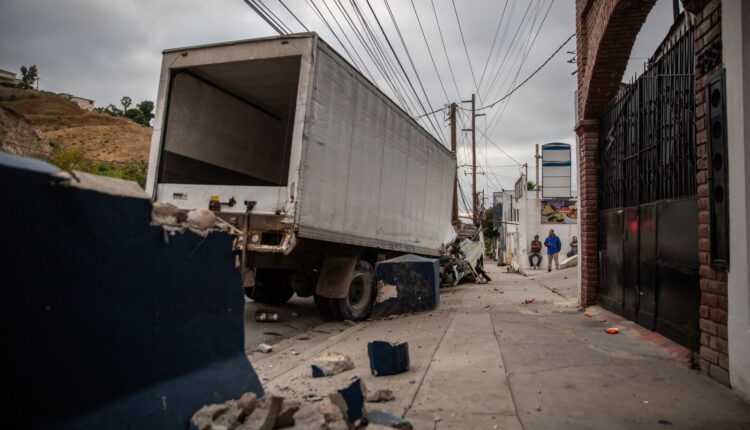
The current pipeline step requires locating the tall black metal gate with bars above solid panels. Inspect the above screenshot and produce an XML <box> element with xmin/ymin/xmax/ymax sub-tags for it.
<box><xmin>598</xmin><ymin>21</ymin><xmax>700</xmax><ymax>347</ymax></box>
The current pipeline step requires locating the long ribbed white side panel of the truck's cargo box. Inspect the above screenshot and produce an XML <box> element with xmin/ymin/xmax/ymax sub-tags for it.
<box><xmin>297</xmin><ymin>41</ymin><xmax>456</xmax><ymax>255</ymax></box>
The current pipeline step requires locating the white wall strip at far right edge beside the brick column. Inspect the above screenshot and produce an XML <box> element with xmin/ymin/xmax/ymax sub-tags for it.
<box><xmin>721</xmin><ymin>0</ymin><xmax>750</xmax><ymax>399</ymax></box>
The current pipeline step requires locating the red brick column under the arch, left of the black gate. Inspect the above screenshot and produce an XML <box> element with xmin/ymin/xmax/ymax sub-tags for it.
<box><xmin>575</xmin><ymin>120</ymin><xmax>599</xmax><ymax>306</ymax></box>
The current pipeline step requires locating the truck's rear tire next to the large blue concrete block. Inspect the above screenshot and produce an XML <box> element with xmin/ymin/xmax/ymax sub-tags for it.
<box><xmin>331</xmin><ymin>260</ymin><xmax>376</xmax><ymax>321</ymax></box>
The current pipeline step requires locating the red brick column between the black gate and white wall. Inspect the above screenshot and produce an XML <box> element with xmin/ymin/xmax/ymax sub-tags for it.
<box><xmin>691</xmin><ymin>0</ymin><xmax>729</xmax><ymax>385</ymax></box>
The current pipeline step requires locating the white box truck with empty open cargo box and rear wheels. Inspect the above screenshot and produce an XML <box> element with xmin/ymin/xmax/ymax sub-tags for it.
<box><xmin>146</xmin><ymin>33</ymin><xmax>478</xmax><ymax>320</ymax></box>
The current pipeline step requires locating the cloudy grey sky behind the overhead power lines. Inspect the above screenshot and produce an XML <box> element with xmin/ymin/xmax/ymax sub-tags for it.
<box><xmin>0</xmin><ymin>0</ymin><xmax>672</xmax><ymax>211</ymax></box>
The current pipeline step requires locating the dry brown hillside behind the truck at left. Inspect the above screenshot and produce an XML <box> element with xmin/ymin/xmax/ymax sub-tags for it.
<box><xmin>0</xmin><ymin>87</ymin><xmax>151</xmax><ymax>163</ymax></box>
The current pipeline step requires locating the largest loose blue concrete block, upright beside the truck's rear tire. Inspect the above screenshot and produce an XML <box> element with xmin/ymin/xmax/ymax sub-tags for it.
<box><xmin>372</xmin><ymin>254</ymin><xmax>440</xmax><ymax>317</ymax></box>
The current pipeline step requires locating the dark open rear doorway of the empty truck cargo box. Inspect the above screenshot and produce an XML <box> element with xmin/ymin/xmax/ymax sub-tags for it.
<box><xmin>158</xmin><ymin>56</ymin><xmax>301</xmax><ymax>191</ymax></box>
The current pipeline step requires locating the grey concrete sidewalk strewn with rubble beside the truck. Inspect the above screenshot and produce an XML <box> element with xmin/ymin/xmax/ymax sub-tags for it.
<box><xmin>249</xmin><ymin>265</ymin><xmax>750</xmax><ymax>429</ymax></box>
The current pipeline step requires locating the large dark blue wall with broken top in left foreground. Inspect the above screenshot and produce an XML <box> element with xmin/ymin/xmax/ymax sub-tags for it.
<box><xmin>0</xmin><ymin>154</ymin><xmax>262</xmax><ymax>428</ymax></box>
